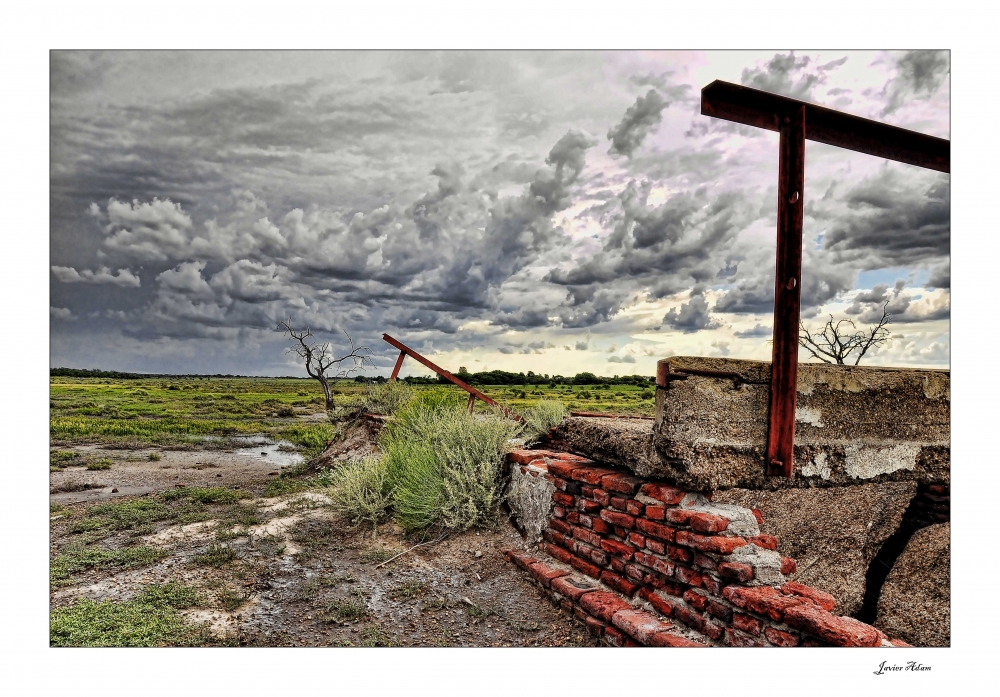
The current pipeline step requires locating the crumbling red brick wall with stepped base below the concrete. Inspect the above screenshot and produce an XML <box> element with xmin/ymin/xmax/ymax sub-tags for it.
<box><xmin>500</xmin><ymin>450</ymin><xmax>904</xmax><ymax>646</ymax></box>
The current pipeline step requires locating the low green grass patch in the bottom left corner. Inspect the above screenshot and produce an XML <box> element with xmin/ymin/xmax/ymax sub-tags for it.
<box><xmin>49</xmin><ymin>583</ymin><xmax>208</xmax><ymax>646</ymax></box>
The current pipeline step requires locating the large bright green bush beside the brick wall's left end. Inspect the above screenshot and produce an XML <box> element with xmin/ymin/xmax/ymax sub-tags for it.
<box><xmin>379</xmin><ymin>399</ymin><xmax>521</xmax><ymax>530</ymax></box>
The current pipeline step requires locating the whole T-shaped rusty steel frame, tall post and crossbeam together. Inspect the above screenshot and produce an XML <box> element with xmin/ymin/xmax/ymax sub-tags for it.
<box><xmin>701</xmin><ymin>80</ymin><xmax>951</xmax><ymax>477</ymax></box>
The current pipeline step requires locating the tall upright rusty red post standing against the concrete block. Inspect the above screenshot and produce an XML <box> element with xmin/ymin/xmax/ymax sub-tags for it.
<box><xmin>767</xmin><ymin>105</ymin><xmax>806</xmax><ymax>477</ymax></box>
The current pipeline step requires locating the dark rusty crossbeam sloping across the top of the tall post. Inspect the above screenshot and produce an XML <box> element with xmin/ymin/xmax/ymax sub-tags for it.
<box><xmin>701</xmin><ymin>80</ymin><xmax>951</xmax><ymax>172</ymax></box>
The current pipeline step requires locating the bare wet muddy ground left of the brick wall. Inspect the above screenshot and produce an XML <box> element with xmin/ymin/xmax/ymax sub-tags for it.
<box><xmin>50</xmin><ymin>444</ymin><xmax>597</xmax><ymax>646</ymax></box>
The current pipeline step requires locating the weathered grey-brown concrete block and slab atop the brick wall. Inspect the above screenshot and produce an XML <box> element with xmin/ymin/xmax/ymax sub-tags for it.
<box><xmin>550</xmin><ymin>356</ymin><xmax>951</xmax><ymax>492</ymax></box>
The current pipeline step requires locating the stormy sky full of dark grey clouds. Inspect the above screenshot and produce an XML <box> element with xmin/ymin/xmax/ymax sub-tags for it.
<box><xmin>50</xmin><ymin>51</ymin><xmax>951</xmax><ymax>375</ymax></box>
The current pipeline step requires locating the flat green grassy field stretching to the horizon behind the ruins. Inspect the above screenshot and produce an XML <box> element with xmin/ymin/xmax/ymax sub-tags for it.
<box><xmin>50</xmin><ymin>377</ymin><xmax>653</xmax><ymax>450</ymax></box>
